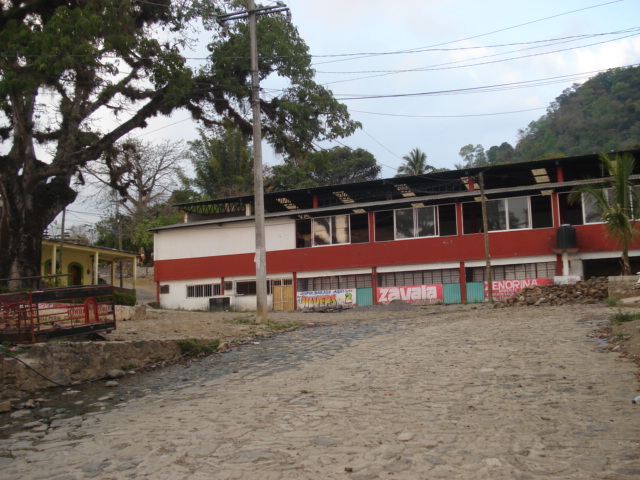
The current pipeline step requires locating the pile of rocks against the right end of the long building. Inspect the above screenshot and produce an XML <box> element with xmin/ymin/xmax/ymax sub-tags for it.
<box><xmin>495</xmin><ymin>277</ymin><xmax>609</xmax><ymax>307</ymax></box>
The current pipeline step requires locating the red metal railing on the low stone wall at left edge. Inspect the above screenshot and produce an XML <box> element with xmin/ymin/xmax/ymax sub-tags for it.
<box><xmin>0</xmin><ymin>286</ymin><xmax>116</xmax><ymax>343</ymax></box>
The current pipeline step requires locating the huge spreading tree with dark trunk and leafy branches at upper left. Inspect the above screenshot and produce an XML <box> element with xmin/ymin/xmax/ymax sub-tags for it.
<box><xmin>0</xmin><ymin>0</ymin><xmax>358</xmax><ymax>286</ymax></box>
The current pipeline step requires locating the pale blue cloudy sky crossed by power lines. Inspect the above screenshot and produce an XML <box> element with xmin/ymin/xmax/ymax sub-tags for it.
<box><xmin>61</xmin><ymin>0</ymin><xmax>640</xmax><ymax>231</ymax></box>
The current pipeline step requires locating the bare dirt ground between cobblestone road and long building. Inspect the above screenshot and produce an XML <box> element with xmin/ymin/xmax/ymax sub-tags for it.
<box><xmin>117</xmin><ymin>271</ymin><xmax>640</xmax><ymax>377</ymax></box>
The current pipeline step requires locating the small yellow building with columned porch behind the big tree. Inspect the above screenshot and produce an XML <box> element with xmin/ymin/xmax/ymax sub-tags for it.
<box><xmin>42</xmin><ymin>240</ymin><xmax>138</xmax><ymax>289</ymax></box>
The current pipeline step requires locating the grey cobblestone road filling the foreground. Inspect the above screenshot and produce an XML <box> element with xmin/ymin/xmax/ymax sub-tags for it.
<box><xmin>0</xmin><ymin>307</ymin><xmax>640</xmax><ymax>480</ymax></box>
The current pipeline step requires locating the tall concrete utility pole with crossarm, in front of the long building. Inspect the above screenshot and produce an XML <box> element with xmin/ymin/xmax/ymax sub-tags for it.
<box><xmin>218</xmin><ymin>0</ymin><xmax>289</xmax><ymax>323</ymax></box>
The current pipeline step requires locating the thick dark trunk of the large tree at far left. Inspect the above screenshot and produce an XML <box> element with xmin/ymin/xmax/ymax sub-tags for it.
<box><xmin>0</xmin><ymin>177</ymin><xmax>76</xmax><ymax>290</ymax></box>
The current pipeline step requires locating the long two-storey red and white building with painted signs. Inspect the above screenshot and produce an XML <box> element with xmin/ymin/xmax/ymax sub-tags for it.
<box><xmin>154</xmin><ymin>151</ymin><xmax>640</xmax><ymax>310</ymax></box>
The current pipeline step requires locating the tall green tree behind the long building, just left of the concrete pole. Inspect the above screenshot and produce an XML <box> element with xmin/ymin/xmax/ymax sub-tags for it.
<box><xmin>186</xmin><ymin>125</ymin><xmax>253</xmax><ymax>198</ymax></box>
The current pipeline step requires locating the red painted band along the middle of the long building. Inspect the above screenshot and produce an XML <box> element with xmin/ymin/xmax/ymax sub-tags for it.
<box><xmin>154</xmin><ymin>225</ymin><xmax>584</xmax><ymax>281</ymax></box>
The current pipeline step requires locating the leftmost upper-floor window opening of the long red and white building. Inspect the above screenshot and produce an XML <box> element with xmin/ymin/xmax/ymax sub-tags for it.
<box><xmin>296</xmin><ymin>213</ymin><xmax>369</xmax><ymax>248</ymax></box>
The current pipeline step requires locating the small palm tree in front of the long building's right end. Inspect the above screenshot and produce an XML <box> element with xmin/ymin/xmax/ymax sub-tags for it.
<box><xmin>569</xmin><ymin>153</ymin><xmax>640</xmax><ymax>275</ymax></box>
